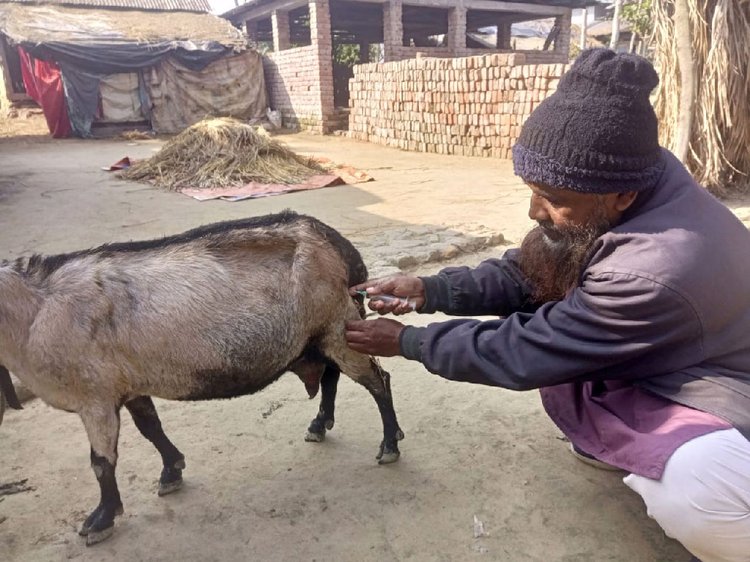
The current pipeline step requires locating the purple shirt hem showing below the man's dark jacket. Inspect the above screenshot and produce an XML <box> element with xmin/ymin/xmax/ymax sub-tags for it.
<box><xmin>540</xmin><ymin>381</ymin><xmax>732</xmax><ymax>474</ymax></box>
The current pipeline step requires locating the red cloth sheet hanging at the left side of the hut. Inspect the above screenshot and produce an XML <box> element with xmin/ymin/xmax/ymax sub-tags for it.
<box><xmin>18</xmin><ymin>47</ymin><xmax>71</xmax><ymax>138</ymax></box>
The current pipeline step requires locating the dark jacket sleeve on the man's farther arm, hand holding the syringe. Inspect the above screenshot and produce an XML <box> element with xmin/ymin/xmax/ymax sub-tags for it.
<box><xmin>420</xmin><ymin>249</ymin><xmax>533</xmax><ymax>316</ymax></box>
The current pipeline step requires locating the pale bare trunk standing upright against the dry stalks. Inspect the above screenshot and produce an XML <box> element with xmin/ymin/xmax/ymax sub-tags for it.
<box><xmin>673</xmin><ymin>0</ymin><xmax>695</xmax><ymax>164</ymax></box>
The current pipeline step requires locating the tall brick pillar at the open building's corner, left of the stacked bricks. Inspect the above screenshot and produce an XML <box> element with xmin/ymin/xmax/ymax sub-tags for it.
<box><xmin>309</xmin><ymin>0</ymin><xmax>335</xmax><ymax>133</ymax></box>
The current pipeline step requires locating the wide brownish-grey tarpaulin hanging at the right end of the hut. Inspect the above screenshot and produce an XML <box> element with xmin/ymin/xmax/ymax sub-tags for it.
<box><xmin>144</xmin><ymin>51</ymin><xmax>267</xmax><ymax>133</ymax></box>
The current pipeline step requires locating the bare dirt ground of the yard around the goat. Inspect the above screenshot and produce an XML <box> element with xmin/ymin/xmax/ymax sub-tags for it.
<box><xmin>0</xmin><ymin>115</ymin><xmax>750</xmax><ymax>562</ymax></box>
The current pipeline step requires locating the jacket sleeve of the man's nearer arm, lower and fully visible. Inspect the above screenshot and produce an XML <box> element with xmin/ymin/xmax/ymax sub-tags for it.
<box><xmin>401</xmin><ymin>272</ymin><xmax>705</xmax><ymax>390</ymax></box>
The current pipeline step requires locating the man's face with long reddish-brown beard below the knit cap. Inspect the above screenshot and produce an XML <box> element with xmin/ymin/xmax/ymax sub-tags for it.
<box><xmin>520</xmin><ymin>185</ymin><xmax>636</xmax><ymax>304</ymax></box>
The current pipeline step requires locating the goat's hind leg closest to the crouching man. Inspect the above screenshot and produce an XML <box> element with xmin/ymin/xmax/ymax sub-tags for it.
<box><xmin>321</xmin><ymin>334</ymin><xmax>404</xmax><ymax>464</ymax></box>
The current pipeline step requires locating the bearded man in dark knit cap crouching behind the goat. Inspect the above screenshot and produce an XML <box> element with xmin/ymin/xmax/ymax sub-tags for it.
<box><xmin>347</xmin><ymin>49</ymin><xmax>750</xmax><ymax>562</ymax></box>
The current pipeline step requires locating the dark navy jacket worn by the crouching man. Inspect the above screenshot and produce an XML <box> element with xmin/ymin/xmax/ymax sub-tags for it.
<box><xmin>401</xmin><ymin>151</ymin><xmax>750</xmax><ymax>438</ymax></box>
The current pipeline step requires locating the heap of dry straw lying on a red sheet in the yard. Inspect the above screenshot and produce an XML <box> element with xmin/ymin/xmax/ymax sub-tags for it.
<box><xmin>120</xmin><ymin>118</ymin><xmax>325</xmax><ymax>191</ymax></box>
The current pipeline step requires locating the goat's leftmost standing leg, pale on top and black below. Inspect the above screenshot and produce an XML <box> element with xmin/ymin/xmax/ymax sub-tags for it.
<box><xmin>79</xmin><ymin>404</ymin><xmax>123</xmax><ymax>546</ymax></box>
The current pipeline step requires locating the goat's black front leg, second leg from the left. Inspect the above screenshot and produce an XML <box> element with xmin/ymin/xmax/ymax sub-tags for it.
<box><xmin>125</xmin><ymin>396</ymin><xmax>185</xmax><ymax>496</ymax></box>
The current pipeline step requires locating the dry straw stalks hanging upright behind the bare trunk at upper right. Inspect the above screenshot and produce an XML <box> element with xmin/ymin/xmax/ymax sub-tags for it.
<box><xmin>653</xmin><ymin>0</ymin><xmax>750</xmax><ymax>196</ymax></box>
